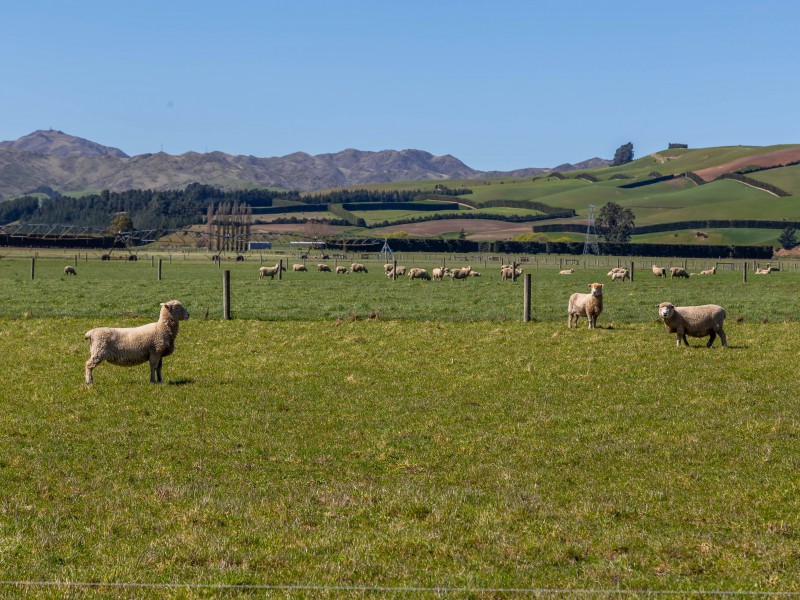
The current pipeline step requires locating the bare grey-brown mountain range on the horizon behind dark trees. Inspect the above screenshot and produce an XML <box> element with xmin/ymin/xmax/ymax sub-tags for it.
<box><xmin>0</xmin><ymin>130</ymin><xmax>611</xmax><ymax>196</ymax></box>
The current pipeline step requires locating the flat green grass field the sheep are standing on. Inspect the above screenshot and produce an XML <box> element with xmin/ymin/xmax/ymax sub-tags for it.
<box><xmin>0</xmin><ymin>251</ymin><xmax>800</xmax><ymax>597</ymax></box>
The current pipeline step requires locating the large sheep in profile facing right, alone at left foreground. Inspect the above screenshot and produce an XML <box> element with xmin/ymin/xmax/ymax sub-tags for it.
<box><xmin>83</xmin><ymin>300</ymin><xmax>189</xmax><ymax>384</ymax></box>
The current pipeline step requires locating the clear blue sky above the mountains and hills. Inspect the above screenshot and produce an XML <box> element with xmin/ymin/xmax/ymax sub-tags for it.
<box><xmin>0</xmin><ymin>0</ymin><xmax>800</xmax><ymax>170</ymax></box>
